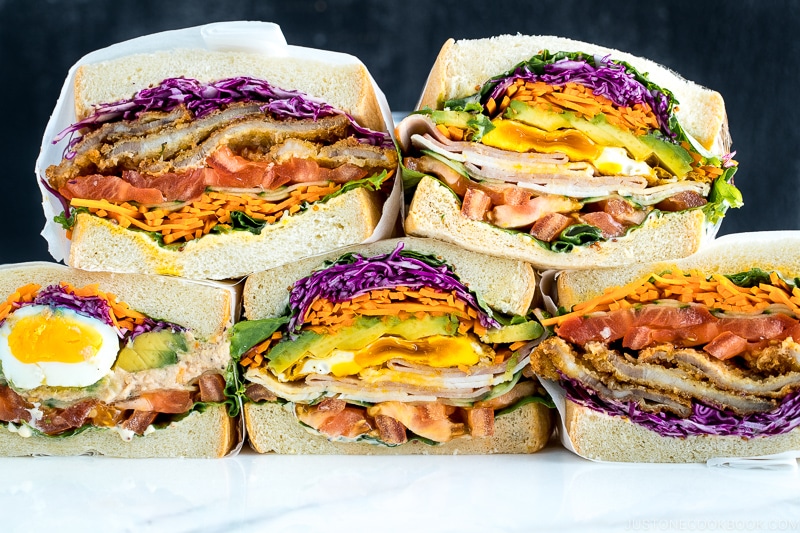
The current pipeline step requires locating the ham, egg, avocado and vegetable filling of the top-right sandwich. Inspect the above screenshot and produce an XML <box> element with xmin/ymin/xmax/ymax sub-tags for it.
<box><xmin>396</xmin><ymin>51</ymin><xmax>741</xmax><ymax>252</ymax></box>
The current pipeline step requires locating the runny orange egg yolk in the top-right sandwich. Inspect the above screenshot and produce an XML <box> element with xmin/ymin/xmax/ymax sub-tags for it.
<box><xmin>481</xmin><ymin>120</ymin><xmax>602</xmax><ymax>161</ymax></box>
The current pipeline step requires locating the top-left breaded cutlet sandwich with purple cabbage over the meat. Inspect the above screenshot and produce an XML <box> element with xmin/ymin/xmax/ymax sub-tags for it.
<box><xmin>40</xmin><ymin>27</ymin><xmax>399</xmax><ymax>279</ymax></box>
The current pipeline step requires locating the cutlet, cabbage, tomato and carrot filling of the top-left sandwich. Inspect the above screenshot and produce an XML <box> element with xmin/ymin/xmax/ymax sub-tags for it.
<box><xmin>45</xmin><ymin>77</ymin><xmax>397</xmax><ymax>245</ymax></box>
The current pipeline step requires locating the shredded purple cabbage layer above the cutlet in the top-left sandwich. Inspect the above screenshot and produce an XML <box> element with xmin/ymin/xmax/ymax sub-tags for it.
<box><xmin>53</xmin><ymin>76</ymin><xmax>392</xmax><ymax>158</ymax></box>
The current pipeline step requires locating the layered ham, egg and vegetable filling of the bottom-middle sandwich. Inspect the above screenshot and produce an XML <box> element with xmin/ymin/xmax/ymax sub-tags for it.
<box><xmin>231</xmin><ymin>244</ymin><xmax>549</xmax><ymax>446</ymax></box>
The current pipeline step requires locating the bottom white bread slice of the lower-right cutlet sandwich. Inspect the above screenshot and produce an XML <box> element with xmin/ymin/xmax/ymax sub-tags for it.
<box><xmin>564</xmin><ymin>400</ymin><xmax>800</xmax><ymax>463</ymax></box>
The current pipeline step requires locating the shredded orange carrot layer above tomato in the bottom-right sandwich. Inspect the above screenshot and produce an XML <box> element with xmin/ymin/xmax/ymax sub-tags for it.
<box><xmin>542</xmin><ymin>269</ymin><xmax>800</xmax><ymax>326</ymax></box>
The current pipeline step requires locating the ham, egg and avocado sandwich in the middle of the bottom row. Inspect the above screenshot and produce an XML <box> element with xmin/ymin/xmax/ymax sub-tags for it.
<box><xmin>231</xmin><ymin>238</ymin><xmax>552</xmax><ymax>454</ymax></box>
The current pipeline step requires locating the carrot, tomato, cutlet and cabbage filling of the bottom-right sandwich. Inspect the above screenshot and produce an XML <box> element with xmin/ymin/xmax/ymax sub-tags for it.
<box><xmin>531</xmin><ymin>269</ymin><xmax>800</xmax><ymax>438</ymax></box>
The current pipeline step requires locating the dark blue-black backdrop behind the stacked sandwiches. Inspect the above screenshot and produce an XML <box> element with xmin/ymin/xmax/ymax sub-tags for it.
<box><xmin>0</xmin><ymin>0</ymin><xmax>800</xmax><ymax>263</ymax></box>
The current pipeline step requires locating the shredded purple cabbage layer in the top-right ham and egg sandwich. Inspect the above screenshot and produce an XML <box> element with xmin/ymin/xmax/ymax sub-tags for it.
<box><xmin>490</xmin><ymin>56</ymin><xmax>675</xmax><ymax>137</ymax></box>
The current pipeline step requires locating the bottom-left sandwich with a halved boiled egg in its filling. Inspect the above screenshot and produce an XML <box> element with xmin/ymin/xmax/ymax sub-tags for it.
<box><xmin>0</xmin><ymin>262</ymin><xmax>242</xmax><ymax>457</ymax></box>
